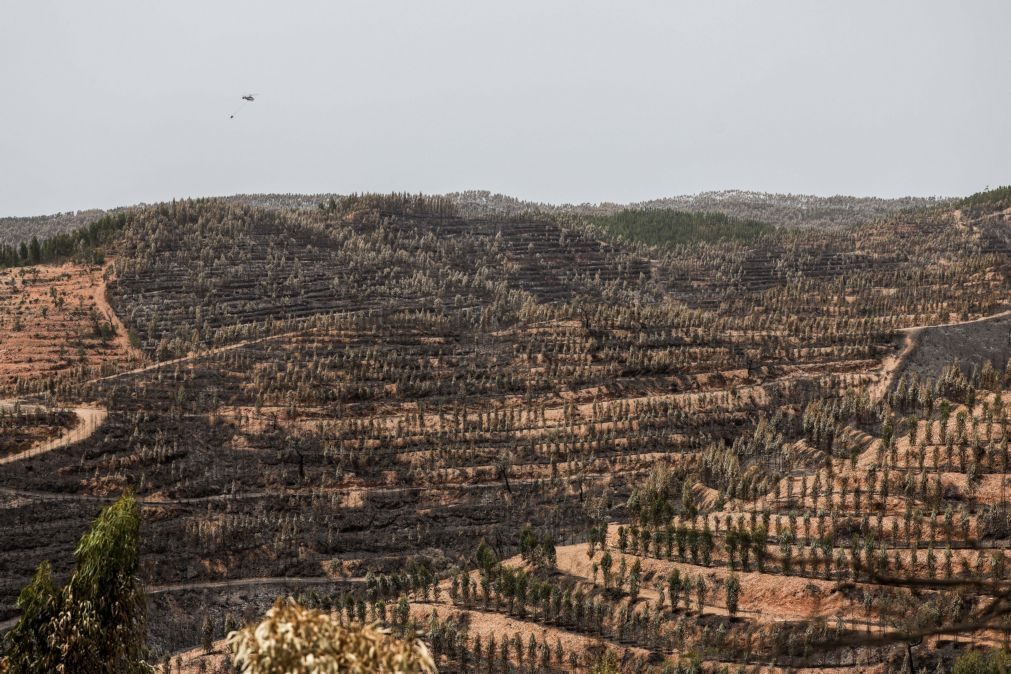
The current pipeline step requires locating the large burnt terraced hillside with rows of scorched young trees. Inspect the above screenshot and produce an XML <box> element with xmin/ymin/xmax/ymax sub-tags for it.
<box><xmin>0</xmin><ymin>193</ymin><xmax>1011</xmax><ymax>672</ymax></box>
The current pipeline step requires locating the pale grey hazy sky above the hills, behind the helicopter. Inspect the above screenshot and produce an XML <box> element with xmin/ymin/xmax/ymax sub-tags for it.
<box><xmin>0</xmin><ymin>0</ymin><xmax>1011</xmax><ymax>215</ymax></box>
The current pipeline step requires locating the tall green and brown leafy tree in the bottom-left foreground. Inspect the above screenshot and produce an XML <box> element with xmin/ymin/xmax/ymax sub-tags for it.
<box><xmin>0</xmin><ymin>493</ymin><xmax>153</xmax><ymax>674</ymax></box>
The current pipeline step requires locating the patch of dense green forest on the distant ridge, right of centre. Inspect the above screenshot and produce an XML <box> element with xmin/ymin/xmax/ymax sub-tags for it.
<box><xmin>590</xmin><ymin>208</ymin><xmax>775</xmax><ymax>247</ymax></box>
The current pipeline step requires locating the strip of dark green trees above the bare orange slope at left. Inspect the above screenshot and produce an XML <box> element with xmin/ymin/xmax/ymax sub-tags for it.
<box><xmin>0</xmin><ymin>213</ymin><xmax>127</xmax><ymax>269</ymax></box>
